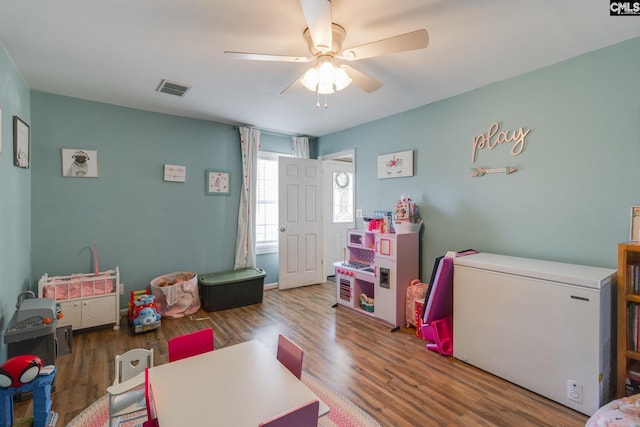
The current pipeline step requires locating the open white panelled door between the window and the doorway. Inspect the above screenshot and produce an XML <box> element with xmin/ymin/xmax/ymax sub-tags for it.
<box><xmin>278</xmin><ymin>157</ymin><xmax>325</xmax><ymax>289</ymax></box>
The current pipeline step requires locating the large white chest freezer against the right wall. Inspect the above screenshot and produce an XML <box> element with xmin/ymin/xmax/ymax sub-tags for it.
<box><xmin>453</xmin><ymin>253</ymin><xmax>616</xmax><ymax>415</ymax></box>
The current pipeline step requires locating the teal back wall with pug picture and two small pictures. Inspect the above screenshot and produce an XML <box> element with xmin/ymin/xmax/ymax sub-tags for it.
<box><xmin>31</xmin><ymin>95</ymin><xmax>300</xmax><ymax>304</ymax></box>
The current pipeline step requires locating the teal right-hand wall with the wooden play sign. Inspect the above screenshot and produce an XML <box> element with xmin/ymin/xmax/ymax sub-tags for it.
<box><xmin>319</xmin><ymin>38</ymin><xmax>640</xmax><ymax>280</ymax></box>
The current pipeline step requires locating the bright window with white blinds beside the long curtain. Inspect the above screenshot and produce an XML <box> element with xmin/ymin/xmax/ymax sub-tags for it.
<box><xmin>256</xmin><ymin>151</ymin><xmax>287</xmax><ymax>254</ymax></box>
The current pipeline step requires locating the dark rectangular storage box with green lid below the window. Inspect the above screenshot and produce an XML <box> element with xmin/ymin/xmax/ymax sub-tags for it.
<box><xmin>198</xmin><ymin>268</ymin><xmax>267</xmax><ymax>311</ymax></box>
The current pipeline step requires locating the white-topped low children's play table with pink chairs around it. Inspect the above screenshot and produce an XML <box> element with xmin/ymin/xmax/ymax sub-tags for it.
<box><xmin>149</xmin><ymin>341</ymin><xmax>329</xmax><ymax>427</ymax></box>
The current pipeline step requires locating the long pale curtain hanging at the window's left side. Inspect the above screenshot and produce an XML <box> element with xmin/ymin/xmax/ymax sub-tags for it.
<box><xmin>233</xmin><ymin>127</ymin><xmax>260</xmax><ymax>270</ymax></box>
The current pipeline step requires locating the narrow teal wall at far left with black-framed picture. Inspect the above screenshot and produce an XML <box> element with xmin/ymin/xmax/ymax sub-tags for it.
<box><xmin>0</xmin><ymin>49</ymin><xmax>32</xmax><ymax>360</ymax></box>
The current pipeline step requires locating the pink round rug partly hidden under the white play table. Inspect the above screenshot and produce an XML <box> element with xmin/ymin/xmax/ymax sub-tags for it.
<box><xmin>67</xmin><ymin>373</ymin><xmax>380</xmax><ymax>427</ymax></box>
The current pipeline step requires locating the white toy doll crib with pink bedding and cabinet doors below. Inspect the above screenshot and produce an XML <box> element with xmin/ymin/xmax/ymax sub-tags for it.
<box><xmin>38</xmin><ymin>267</ymin><xmax>121</xmax><ymax>331</ymax></box>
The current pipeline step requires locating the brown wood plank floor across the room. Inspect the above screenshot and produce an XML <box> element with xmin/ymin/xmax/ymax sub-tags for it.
<box><xmin>15</xmin><ymin>282</ymin><xmax>587</xmax><ymax>427</ymax></box>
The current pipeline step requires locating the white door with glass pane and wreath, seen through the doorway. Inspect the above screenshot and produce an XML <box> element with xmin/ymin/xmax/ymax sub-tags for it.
<box><xmin>323</xmin><ymin>160</ymin><xmax>355</xmax><ymax>276</ymax></box>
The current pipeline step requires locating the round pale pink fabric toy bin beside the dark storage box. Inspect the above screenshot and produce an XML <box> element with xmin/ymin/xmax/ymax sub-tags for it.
<box><xmin>151</xmin><ymin>271</ymin><xmax>200</xmax><ymax>319</ymax></box>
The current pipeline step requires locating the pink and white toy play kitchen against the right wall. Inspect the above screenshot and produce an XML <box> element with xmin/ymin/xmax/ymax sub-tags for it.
<box><xmin>334</xmin><ymin>229</ymin><xmax>418</xmax><ymax>331</ymax></box>
